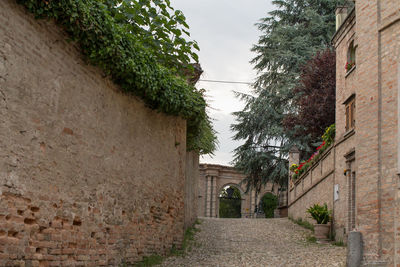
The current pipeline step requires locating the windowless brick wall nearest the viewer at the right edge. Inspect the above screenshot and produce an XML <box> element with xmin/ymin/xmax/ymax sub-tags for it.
<box><xmin>356</xmin><ymin>0</ymin><xmax>400</xmax><ymax>266</ymax></box>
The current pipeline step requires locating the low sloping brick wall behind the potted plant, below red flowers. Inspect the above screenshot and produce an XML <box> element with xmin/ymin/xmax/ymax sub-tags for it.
<box><xmin>288</xmin><ymin>143</ymin><xmax>354</xmax><ymax>243</ymax></box>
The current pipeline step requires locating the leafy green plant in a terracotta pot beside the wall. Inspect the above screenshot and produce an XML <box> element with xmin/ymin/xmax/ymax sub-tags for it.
<box><xmin>307</xmin><ymin>203</ymin><xmax>332</xmax><ymax>240</ymax></box>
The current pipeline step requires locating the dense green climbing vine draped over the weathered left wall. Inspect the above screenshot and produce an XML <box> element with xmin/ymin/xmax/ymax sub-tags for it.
<box><xmin>17</xmin><ymin>0</ymin><xmax>216</xmax><ymax>154</ymax></box>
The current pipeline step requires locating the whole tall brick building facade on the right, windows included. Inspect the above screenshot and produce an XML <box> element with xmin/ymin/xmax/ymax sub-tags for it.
<box><xmin>333</xmin><ymin>0</ymin><xmax>400</xmax><ymax>266</ymax></box>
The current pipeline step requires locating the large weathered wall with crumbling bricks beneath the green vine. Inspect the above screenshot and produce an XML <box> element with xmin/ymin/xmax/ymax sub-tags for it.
<box><xmin>0</xmin><ymin>0</ymin><xmax>186</xmax><ymax>266</ymax></box>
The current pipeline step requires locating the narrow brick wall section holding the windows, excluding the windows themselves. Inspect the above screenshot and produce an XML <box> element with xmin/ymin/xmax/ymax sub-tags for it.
<box><xmin>333</xmin><ymin>9</ymin><xmax>359</xmax><ymax>247</ymax></box>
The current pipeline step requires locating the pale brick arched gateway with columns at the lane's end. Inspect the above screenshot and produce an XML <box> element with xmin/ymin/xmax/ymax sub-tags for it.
<box><xmin>198</xmin><ymin>164</ymin><xmax>284</xmax><ymax>218</ymax></box>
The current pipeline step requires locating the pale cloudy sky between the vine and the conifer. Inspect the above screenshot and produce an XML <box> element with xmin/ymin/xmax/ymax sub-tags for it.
<box><xmin>171</xmin><ymin>0</ymin><xmax>272</xmax><ymax>165</ymax></box>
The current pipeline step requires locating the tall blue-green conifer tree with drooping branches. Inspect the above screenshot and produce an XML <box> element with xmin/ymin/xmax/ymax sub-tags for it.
<box><xmin>231</xmin><ymin>0</ymin><xmax>350</xmax><ymax>193</ymax></box>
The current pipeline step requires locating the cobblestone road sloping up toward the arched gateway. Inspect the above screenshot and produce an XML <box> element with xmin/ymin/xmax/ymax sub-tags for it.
<box><xmin>162</xmin><ymin>218</ymin><xmax>346</xmax><ymax>267</ymax></box>
